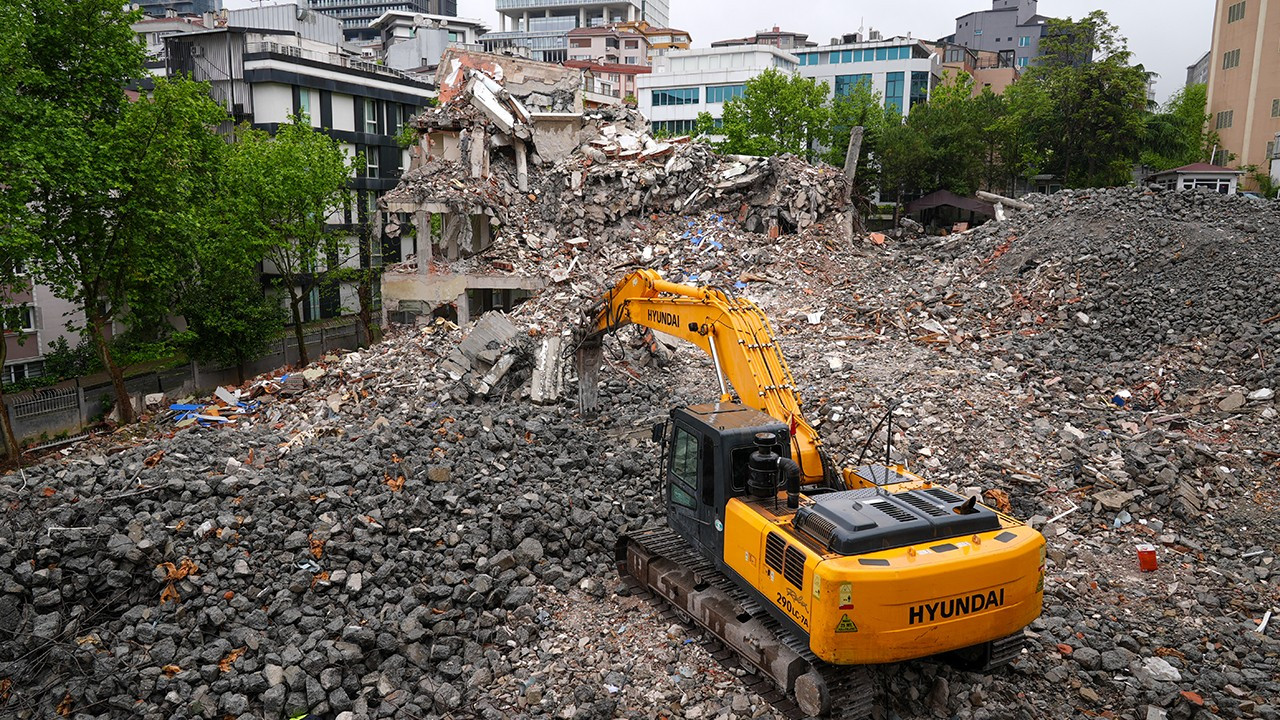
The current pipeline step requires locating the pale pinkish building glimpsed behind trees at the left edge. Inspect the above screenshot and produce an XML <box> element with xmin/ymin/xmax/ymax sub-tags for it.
<box><xmin>0</xmin><ymin>284</ymin><xmax>84</xmax><ymax>383</ymax></box>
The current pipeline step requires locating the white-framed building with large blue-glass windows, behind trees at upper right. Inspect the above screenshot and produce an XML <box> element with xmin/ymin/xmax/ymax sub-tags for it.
<box><xmin>796</xmin><ymin>36</ymin><xmax>942</xmax><ymax>115</ymax></box>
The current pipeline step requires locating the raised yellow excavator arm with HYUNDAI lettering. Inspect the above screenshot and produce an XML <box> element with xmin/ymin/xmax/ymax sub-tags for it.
<box><xmin>577</xmin><ymin>270</ymin><xmax>835</xmax><ymax>484</ymax></box>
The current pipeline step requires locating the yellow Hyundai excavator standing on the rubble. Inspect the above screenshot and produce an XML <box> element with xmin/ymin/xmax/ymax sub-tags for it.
<box><xmin>577</xmin><ymin>270</ymin><xmax>1044</xmax><ymax>720</ymax></box>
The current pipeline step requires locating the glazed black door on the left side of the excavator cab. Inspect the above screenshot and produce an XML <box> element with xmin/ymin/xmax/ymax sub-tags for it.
<box><xmin>666</xmin><ymin>423</ymin><xmax>722</xmax><ymax>560</ymax></box>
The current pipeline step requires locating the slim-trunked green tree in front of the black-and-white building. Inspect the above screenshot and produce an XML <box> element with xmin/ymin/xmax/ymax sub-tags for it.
<box><xmin>229</xmin><ymin>118</ymin><xmax>360</xmax><ymax>365</ymax></box>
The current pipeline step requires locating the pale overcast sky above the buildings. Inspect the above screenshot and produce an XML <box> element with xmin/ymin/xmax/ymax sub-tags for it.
<box><xmin>224</xmin><ymin>0</ymin><xmax>1213</xmax><ymax>102</ymax></box>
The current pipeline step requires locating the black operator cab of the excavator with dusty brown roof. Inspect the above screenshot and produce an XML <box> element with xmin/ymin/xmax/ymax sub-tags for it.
<box><xmin>655</xmin><ymin>402</ymin><xmax>790</xmax><ymax>568</ymax></box>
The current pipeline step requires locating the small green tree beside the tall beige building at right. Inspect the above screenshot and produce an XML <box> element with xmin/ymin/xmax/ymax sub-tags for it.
<box><xmin>1142</xmin><ymin>83</ymin><xmax>1217</xmax><ymax>173</ymax></box>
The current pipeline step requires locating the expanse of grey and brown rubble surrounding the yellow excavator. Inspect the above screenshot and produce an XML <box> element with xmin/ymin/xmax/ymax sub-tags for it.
<box><xmin>0</xmin><ymin>185</ymin><xmax>1280</xmax><ymax>720</ymax></box>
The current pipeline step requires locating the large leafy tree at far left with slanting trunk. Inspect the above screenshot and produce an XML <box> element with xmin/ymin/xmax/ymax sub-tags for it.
<box><xmin>0</xmin><ymin>0</ymin><xmax>225</xmax><ymax>423</ymax></box>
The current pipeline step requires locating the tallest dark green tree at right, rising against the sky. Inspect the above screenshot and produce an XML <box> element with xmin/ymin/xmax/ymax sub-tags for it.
<box><xmin>1006</xmin><ymin>10</ymin><xmax>1147</xmax><ymax>187</ymax></box>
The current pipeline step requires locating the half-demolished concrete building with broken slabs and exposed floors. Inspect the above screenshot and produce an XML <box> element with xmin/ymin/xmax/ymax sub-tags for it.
<box><xmin>379</xmin><ymin>50</ymin><xmax>851</xmax><ymax>323</ymax></box>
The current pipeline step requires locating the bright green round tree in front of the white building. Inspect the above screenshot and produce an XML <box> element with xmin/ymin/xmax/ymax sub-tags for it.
<box><xmin>719</xmin><ymin>68</ymin><xmax>829</xmax><ymax>160</ymax></box>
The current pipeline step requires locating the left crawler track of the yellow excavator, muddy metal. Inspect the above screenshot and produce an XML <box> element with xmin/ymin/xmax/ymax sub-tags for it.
<box><xmin>616</xmin><ymin>524</ymin><xmax>876</xmax><ymax>720</ymax></box>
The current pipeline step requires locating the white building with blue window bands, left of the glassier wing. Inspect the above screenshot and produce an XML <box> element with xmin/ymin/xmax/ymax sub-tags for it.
<box><xmin>636</xmin><ymin>45</ymin><xmax>800</xmax><ymax>135</ymax></box>
